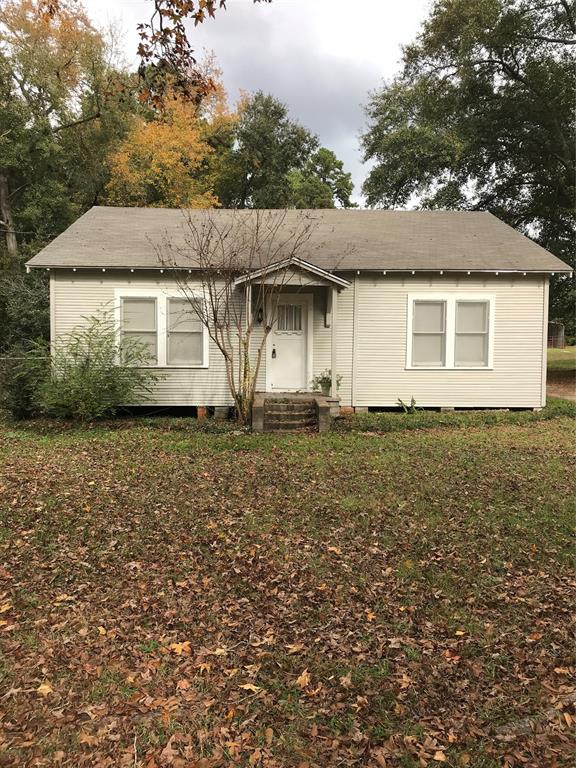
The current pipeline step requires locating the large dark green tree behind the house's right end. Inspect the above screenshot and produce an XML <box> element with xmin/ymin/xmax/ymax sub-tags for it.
<box><xmin>362</xmin><ymin>0</ymin><xmax>576</xmax><ymax>333</ymax></box>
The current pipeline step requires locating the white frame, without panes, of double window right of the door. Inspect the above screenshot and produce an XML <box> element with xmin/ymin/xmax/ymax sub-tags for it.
<box><xmin>405</xmin><ymin>293</ymin><xmax>496</xmax><ymax>371</ymax></box>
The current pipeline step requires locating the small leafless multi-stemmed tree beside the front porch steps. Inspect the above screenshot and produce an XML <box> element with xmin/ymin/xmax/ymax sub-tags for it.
<box><xmin>157</xmin><ymin>210</ymin><xmax>314</xmax><ymax>424</ymax></box>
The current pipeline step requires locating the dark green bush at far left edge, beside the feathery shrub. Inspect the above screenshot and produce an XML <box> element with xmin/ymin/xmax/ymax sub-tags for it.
<box><xmin>0</xmin><ymin>341</ymin><xmax>50</xmax><ymax>419</ymax></box>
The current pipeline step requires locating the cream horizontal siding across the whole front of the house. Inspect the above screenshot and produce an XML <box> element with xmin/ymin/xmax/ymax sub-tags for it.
<box><xmin>52</xmin><ymin>271</ymin><xmax>545</xmax><ymax>407</ymax></box>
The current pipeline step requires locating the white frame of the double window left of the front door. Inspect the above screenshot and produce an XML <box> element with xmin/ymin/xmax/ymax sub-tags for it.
<box><xmin>114</xmin><ymin>288</ymin><xmax>210</xmax><ymax>370</ymax></box>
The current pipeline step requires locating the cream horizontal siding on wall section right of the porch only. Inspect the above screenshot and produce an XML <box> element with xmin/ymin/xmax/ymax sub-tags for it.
<box><xmin>353</xmin><ymin>275</ymin><xmax>545</xmax><ymax>408</ymax></box>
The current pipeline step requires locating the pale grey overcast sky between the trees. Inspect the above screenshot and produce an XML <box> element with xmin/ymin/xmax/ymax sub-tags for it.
<box><xmin>84</xmin><ymin>0</ymin><xmax>430</xmax><ymax>200</ymax></box>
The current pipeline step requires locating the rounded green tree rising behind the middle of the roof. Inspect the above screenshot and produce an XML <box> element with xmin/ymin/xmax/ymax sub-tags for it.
<box><xmin>215</xmin><ymin>91</ymin><xmax>353</xmax><ymax>208</ymax></box>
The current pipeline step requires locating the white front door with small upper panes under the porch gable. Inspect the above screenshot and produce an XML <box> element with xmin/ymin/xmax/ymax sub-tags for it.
<box><xmin>266</xmin><ymin>295</ymin><xmax>309</xmax><ymax>392</ymax></box>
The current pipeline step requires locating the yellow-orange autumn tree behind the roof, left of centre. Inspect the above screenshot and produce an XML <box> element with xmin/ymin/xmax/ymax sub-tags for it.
<box><xmin>106</xmin><ymin>95</ymin><xmax>218</xmax><ymax>208</ymax></box>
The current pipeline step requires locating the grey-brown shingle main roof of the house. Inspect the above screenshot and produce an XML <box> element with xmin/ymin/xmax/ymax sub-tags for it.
<box><xmin>28</xmin><ymin>207</ymin><xmax>571</xmax><ymax>272</ymax></box>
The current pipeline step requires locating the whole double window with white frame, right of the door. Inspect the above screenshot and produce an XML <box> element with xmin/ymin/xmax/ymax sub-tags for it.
<box><xmin>406</xmin><ymin>293</ymin><xmax>496</xmax><ymax>369</ymax></box>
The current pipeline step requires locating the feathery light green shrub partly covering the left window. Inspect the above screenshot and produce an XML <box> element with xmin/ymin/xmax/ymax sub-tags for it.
<box><xmin>40</xmin><ymin>312</ymin><xmax>158</xmax><ymax>421</ymax></box>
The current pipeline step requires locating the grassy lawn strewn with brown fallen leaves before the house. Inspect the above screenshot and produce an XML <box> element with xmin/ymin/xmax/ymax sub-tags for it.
<box><xmin>0</xmin><ymin>415</ymin><xmax>576</xmax><ymax>768</ymax></box>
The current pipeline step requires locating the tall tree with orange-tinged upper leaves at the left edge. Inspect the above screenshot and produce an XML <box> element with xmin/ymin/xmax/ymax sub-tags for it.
<box><xmin>0</xmin><ymin>0</ymin><xmax>137</xmax><ymax>350</ymax></box>
